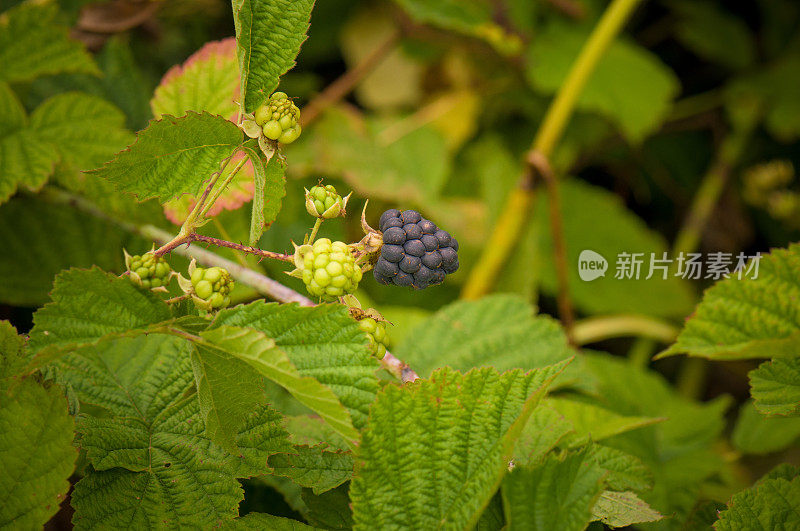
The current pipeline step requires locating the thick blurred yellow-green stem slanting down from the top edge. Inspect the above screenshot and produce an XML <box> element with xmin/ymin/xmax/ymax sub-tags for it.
<box><xmin>461</xmin><ymin>0</ymin><xmax>641</xmax><ymax>299</ymax></box>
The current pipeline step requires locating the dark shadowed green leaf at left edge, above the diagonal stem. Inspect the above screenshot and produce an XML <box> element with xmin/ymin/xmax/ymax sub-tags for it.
<box><xmin>0</xmin><ymin>197</ymin><xmax>149</xmax><ymax>307</ymax></box>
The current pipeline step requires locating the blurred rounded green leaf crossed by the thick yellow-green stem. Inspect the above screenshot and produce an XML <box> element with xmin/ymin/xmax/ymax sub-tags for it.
<box><xmin>526</xmin><ymin>22</ymin><xmax>680</xmax><ymax>143</ymax></box>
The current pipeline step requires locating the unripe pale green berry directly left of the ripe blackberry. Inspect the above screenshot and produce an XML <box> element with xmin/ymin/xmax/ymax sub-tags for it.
<box><xmin>302</xmin><ymin>238</ymin><xmax>362</xmax><ymax>301</ymax></box>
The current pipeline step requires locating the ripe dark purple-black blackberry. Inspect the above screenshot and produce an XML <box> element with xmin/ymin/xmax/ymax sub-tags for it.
<box><xmin>373</xmin><ymin>208</ymin><xmax>458</xmax><ymax>289</ymax></box>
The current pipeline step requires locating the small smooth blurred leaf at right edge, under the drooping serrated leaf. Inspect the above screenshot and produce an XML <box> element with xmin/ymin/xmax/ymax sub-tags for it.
<box><xmin>731</xmin><ymin>400</ymin><xmax>800</xmax><ymax>454</ymax></box>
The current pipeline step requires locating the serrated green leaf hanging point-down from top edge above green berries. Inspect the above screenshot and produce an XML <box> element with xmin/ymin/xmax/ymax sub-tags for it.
<box><xmin>233</xmin><ymin>0</ymin><xmax>314</xmax><ymax>112</ymax></box>
